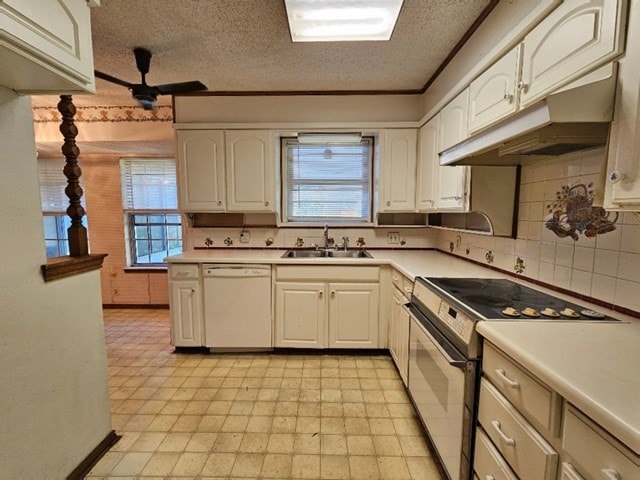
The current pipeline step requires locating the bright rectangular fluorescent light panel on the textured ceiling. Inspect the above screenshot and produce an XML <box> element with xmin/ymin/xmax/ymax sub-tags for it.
<box><xmin>285</xmin><ymin>0</ymin><xmax>403</xmax><ymax>42</ymax></box>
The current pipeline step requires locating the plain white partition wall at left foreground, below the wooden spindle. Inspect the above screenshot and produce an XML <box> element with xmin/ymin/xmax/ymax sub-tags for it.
<box><xmin>0</xmin><ymin>87</ymin><xmax>112</xmax><ymax>479</ymax></box>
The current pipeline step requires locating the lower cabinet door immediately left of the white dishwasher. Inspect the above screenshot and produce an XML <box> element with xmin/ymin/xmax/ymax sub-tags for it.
<box><xmin>169</xmin><ymin>280</ymin><xmax>203</xmax><ymax>347</ymax></box>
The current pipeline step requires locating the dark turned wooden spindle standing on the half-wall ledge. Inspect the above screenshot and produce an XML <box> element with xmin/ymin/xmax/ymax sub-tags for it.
<box><xmin>58</xmin><ymin>95</ymin><xmax>89</xmax><ymax>257</ymax></box>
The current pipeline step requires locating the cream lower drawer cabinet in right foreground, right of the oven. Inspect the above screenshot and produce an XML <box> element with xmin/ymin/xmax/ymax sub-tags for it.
<box><xmin>473</xmin><ymin>342</ymin><xmax>640</xmax><ymax>480</ymax></box>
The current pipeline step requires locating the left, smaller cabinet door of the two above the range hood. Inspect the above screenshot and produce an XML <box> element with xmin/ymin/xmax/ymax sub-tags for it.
<box><xmin>469</xmin><ymin>45</ymin><xmax>520</xmax><ymax>133</ymax></box>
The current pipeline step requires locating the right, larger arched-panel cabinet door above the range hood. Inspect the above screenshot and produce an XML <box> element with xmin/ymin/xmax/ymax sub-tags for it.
<box><xmin>519</xmin><ymin>0</ymin><xmax>626</xmax><ymax>107</ymax></box>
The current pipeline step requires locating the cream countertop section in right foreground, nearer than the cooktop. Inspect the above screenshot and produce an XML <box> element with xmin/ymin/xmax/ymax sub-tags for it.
<box><xmin>477</xmin><ymin>321</ymin><xmax>640</xmax><ymax>454</ymax></box>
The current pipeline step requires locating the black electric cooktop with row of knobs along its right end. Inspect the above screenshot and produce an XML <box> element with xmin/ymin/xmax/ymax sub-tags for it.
<box><xmin>421</xmin><ymin>277</ymin><xmax>617</xmax><ymax>321</ymax></box>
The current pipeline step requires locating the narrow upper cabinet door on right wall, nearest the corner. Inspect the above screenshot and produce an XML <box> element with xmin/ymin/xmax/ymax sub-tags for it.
<box><xmin>416</xmin><ymin>116</ymin><xmax>440</xmax><ymax>212</ymax></box>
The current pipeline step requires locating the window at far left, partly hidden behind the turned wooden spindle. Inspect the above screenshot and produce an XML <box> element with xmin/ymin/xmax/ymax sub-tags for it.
<box><xmin>38</xmin><ymin>158</ymin><xmax>87</xmax><ymax>258</ymax></box>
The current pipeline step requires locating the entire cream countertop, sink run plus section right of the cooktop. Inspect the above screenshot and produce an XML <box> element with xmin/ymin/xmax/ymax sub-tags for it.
<box><xmin>167</xmin><ymin>249</ymin><xmax>640</xmax><ymax>454</ymax></box>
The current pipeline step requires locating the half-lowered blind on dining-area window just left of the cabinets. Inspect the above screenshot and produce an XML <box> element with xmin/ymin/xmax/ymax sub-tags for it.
<box><xmin>120</xmin><ymin>158</ymin><xmax>178</xmax><ymax>210</ymax></box>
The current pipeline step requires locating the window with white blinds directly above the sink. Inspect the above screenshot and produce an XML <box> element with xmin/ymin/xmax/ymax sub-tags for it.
<box><xmin>282</xmin><ymin>134</ymin><xmax>373</xmax><ymax>223</ymax></box>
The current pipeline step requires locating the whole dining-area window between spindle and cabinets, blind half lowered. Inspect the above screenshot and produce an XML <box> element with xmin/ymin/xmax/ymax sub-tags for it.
<box><xmin>120</xmin><ymin>158</ymin><xmax>182</xmax><ymax>267</ymax></box>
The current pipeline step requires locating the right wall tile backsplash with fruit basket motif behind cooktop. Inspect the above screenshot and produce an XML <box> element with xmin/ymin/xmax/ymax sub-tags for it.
<box><xmin>437</xmin><ymin>149</ymin><xmax>640</xmax><ymax>312</ymax></box>
